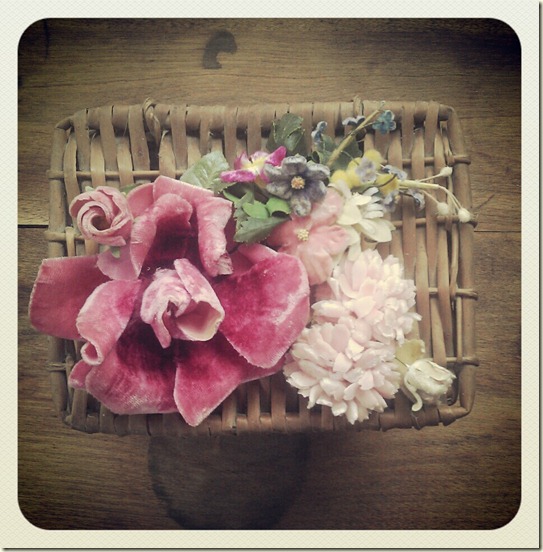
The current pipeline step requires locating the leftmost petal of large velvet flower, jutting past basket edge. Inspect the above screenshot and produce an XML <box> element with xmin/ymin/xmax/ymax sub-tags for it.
<box><xmin>29</xmin><ymin>255</ymin><xmax>109</xmax><ymax>339</ymax></box>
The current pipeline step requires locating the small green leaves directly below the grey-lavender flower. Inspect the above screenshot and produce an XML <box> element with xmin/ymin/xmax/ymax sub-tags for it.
<box><xmin>223</xmin><ymin>187</ymin><xmax>290</xmax><ymax>243</ymax></box>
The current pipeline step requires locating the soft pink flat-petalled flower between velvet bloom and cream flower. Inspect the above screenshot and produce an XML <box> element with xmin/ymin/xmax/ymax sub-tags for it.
<box><xmin>267</xmin><ymin>188</ymin><xmax>349</xmax><ymax>285</ymax></box>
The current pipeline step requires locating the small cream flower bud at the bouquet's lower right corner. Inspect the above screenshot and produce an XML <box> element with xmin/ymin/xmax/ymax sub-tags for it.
<box><xmin>396</xmin><ymin>339</ymin><xmax>456</xmax><ymax>412</ymax></box>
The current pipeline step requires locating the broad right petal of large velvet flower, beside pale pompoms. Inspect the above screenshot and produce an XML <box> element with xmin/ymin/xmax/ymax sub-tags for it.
<box><xmin>214</xmin><ymin>249</ymin><xmax>309</xmax><ymax>368</ymax></box>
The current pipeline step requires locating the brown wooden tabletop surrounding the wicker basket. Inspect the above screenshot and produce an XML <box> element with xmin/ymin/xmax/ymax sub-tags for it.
<box><xmin>19</xmin><ymin>19</ymin><xmax>521</xmax><ymax>532</ymax></box>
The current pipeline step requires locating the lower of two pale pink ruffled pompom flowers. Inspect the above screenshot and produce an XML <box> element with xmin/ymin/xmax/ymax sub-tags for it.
<box><xmin>284</xmin><ymin>317</ymin><xmax>400</xmax><ymax>424</ymax></box>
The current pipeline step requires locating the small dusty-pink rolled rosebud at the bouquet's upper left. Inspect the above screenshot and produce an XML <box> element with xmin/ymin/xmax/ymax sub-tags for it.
<box><xmin>70</xmin><ymin>186</ymin><xmax>132</xmax><ymax>247</ymax></box>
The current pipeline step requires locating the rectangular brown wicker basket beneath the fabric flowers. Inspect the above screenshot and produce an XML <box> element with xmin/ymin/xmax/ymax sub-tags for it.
<box><xmin>42</xmin><ymin>98</ymin><xmax>478</xmax><ymax>436</ymax></box>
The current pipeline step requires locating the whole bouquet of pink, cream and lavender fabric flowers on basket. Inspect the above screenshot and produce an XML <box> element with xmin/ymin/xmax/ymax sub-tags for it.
<box><xmin>30</xmin><ymin>106</ymin><xmax>471</xmax><ymax>426</ymax></box>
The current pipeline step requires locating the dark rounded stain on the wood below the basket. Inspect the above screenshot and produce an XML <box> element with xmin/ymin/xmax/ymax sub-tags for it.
<box><xmin>148</xmin><ymin>434</ymin><xmax>309</xmax><ymax>529</ymax></box>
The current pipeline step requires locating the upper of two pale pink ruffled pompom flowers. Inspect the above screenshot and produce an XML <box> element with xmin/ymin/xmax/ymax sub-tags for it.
<box><xmin>313</xmin><ymin>249</ymin><xmax>421</xmax><ymax>344</ymax></box>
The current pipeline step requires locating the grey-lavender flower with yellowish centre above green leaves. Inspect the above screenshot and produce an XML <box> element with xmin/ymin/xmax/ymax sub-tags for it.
<box><xmin>264</xmin><ymin>155</ymin><xmax>330</xmax><ymax>217</ymax></box>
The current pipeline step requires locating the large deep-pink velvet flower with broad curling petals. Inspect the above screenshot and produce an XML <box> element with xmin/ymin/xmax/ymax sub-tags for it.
<box><xmin>30</xmin><ymin>176</ymin><xmax>309</xmax><ymax>426</ymax></box>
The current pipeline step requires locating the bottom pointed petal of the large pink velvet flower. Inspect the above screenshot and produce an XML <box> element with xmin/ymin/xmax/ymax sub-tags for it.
<box><xmin>174</xmin><ymin>333</ymin><xmax>280</xmax><ymax>426</ymax></box>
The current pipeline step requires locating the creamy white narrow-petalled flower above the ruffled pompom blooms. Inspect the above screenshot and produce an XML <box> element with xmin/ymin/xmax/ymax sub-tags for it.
<box><xmin>331</xmin><ymin>181</ymin><xmax>394</xmax><ymax>259</ymax></box>
